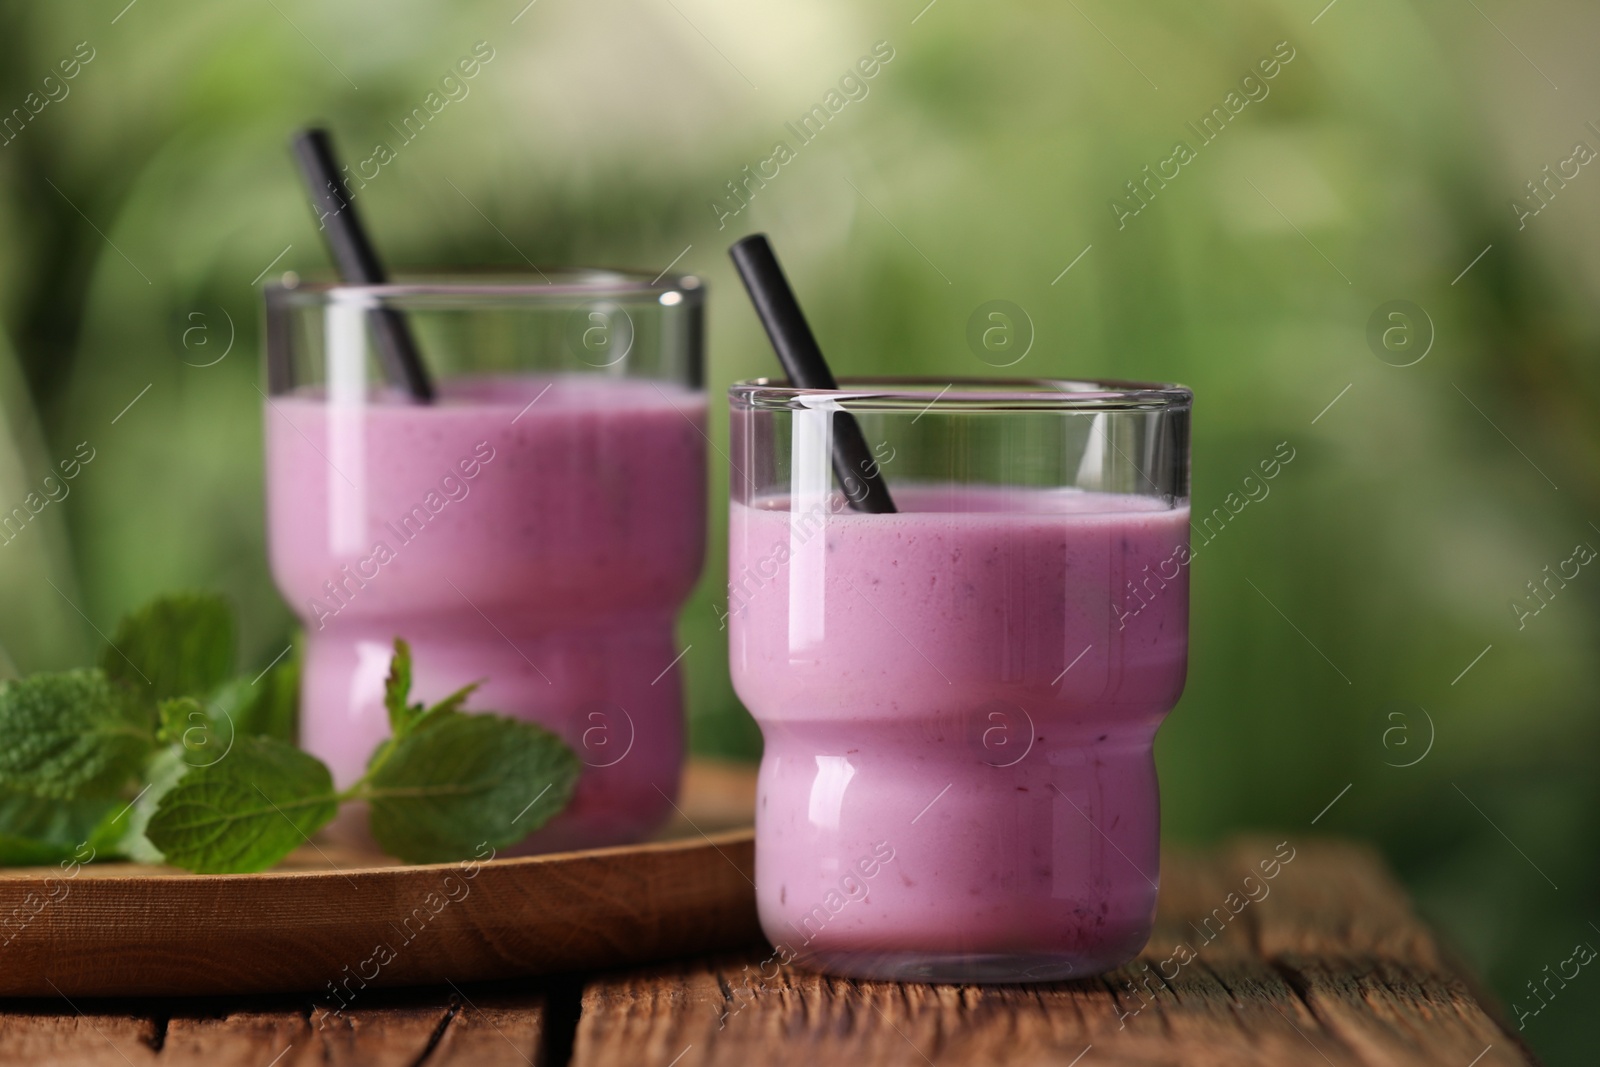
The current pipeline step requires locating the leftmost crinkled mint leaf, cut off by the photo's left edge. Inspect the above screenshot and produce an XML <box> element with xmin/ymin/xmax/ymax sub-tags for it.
<box><xmin>0</xmin><ymin>670</ymin><xmax>155</xmax><ymax>800</ymax></box>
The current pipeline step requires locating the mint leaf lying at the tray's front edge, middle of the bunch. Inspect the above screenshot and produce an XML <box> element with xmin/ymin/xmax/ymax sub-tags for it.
<box><xmin>144</xmin><ymin>737</ymin><xmax>339</xmax><ymax>873</ymax></box>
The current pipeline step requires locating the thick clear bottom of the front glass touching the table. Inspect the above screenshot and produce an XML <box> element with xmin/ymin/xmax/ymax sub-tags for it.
<box><xmin>795</xmin><ymin>950</ymin><xmax>1136</xmax><ymax>985</ymax></box>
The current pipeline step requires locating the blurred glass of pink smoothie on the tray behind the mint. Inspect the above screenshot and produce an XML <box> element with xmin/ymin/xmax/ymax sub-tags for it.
<box><xmin>264</xmin><ymin>270</ymin><xmax>706</xmax><ymax>851</ymax></box>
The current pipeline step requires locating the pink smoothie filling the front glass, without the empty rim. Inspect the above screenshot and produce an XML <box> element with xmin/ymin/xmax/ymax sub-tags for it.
<box><xmin>730</xmin><ymin>485</ymin><xmax>1189</xmax><ymax>981</ymax></box>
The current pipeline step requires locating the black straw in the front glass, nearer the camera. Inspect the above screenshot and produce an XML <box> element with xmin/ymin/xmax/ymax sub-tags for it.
<box><xmin>728</xmin><ymin>234</ymin><xmax>894</xmax><ymax>515</ymax></box>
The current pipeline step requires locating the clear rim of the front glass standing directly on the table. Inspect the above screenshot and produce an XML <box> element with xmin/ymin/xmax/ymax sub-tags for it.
<box><xmin>728</xmin><ymin>378</ymin><xmax>1194</xmax><ymax>411</ymax></box>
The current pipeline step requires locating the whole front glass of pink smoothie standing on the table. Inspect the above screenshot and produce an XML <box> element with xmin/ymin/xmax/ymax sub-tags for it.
<box><xmin>728</xmin><ymin>379</ymin><xmax>1192</xmax><ymax>982</ymax></box>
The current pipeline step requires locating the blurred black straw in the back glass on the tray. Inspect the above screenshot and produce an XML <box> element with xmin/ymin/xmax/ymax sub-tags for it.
<box><xmin>291</xmin><ymin>128</ymin><xmax>434</xmax><ymax>403</ymax></box>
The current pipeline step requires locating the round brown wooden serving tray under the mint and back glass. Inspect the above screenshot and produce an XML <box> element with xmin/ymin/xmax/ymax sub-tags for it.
<box><xmin>0</xmin><ymin>763</ymin><xmax>760</xmax><ymax>1003</ymax></box>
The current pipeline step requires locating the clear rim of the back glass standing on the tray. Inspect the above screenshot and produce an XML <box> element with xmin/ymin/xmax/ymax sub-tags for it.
<box><xmin>262</xmin><ymin>267</ymin><xmax>706</xmax><ymax>306</ymax></box>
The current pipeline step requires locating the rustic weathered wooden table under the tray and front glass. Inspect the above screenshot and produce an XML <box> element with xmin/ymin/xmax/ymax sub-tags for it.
<box><xmin>0</xmin><ymin>840</ymin><xmax>1534</xmax><ymax>1067</ymax></box>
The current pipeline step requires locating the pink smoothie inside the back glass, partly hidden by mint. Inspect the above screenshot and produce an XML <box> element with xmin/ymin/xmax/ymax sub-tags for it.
<box><xmin>266</xmin><ymin>376</ymin><xmax>706</xmax><ymax>851</ymax></box>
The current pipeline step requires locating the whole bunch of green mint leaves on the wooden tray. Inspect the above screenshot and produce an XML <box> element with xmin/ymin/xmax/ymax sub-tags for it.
<box><xmin>0</xmin><ymin>593</ymin><xmax>581</xmax><ymax>873</ymax></box>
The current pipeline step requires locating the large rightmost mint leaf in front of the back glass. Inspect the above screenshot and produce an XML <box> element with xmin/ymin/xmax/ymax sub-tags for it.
<box><xmin>358</xmin><ymin>709</ymin><xmax>581</xmax><ymax>864</ymax></box>
